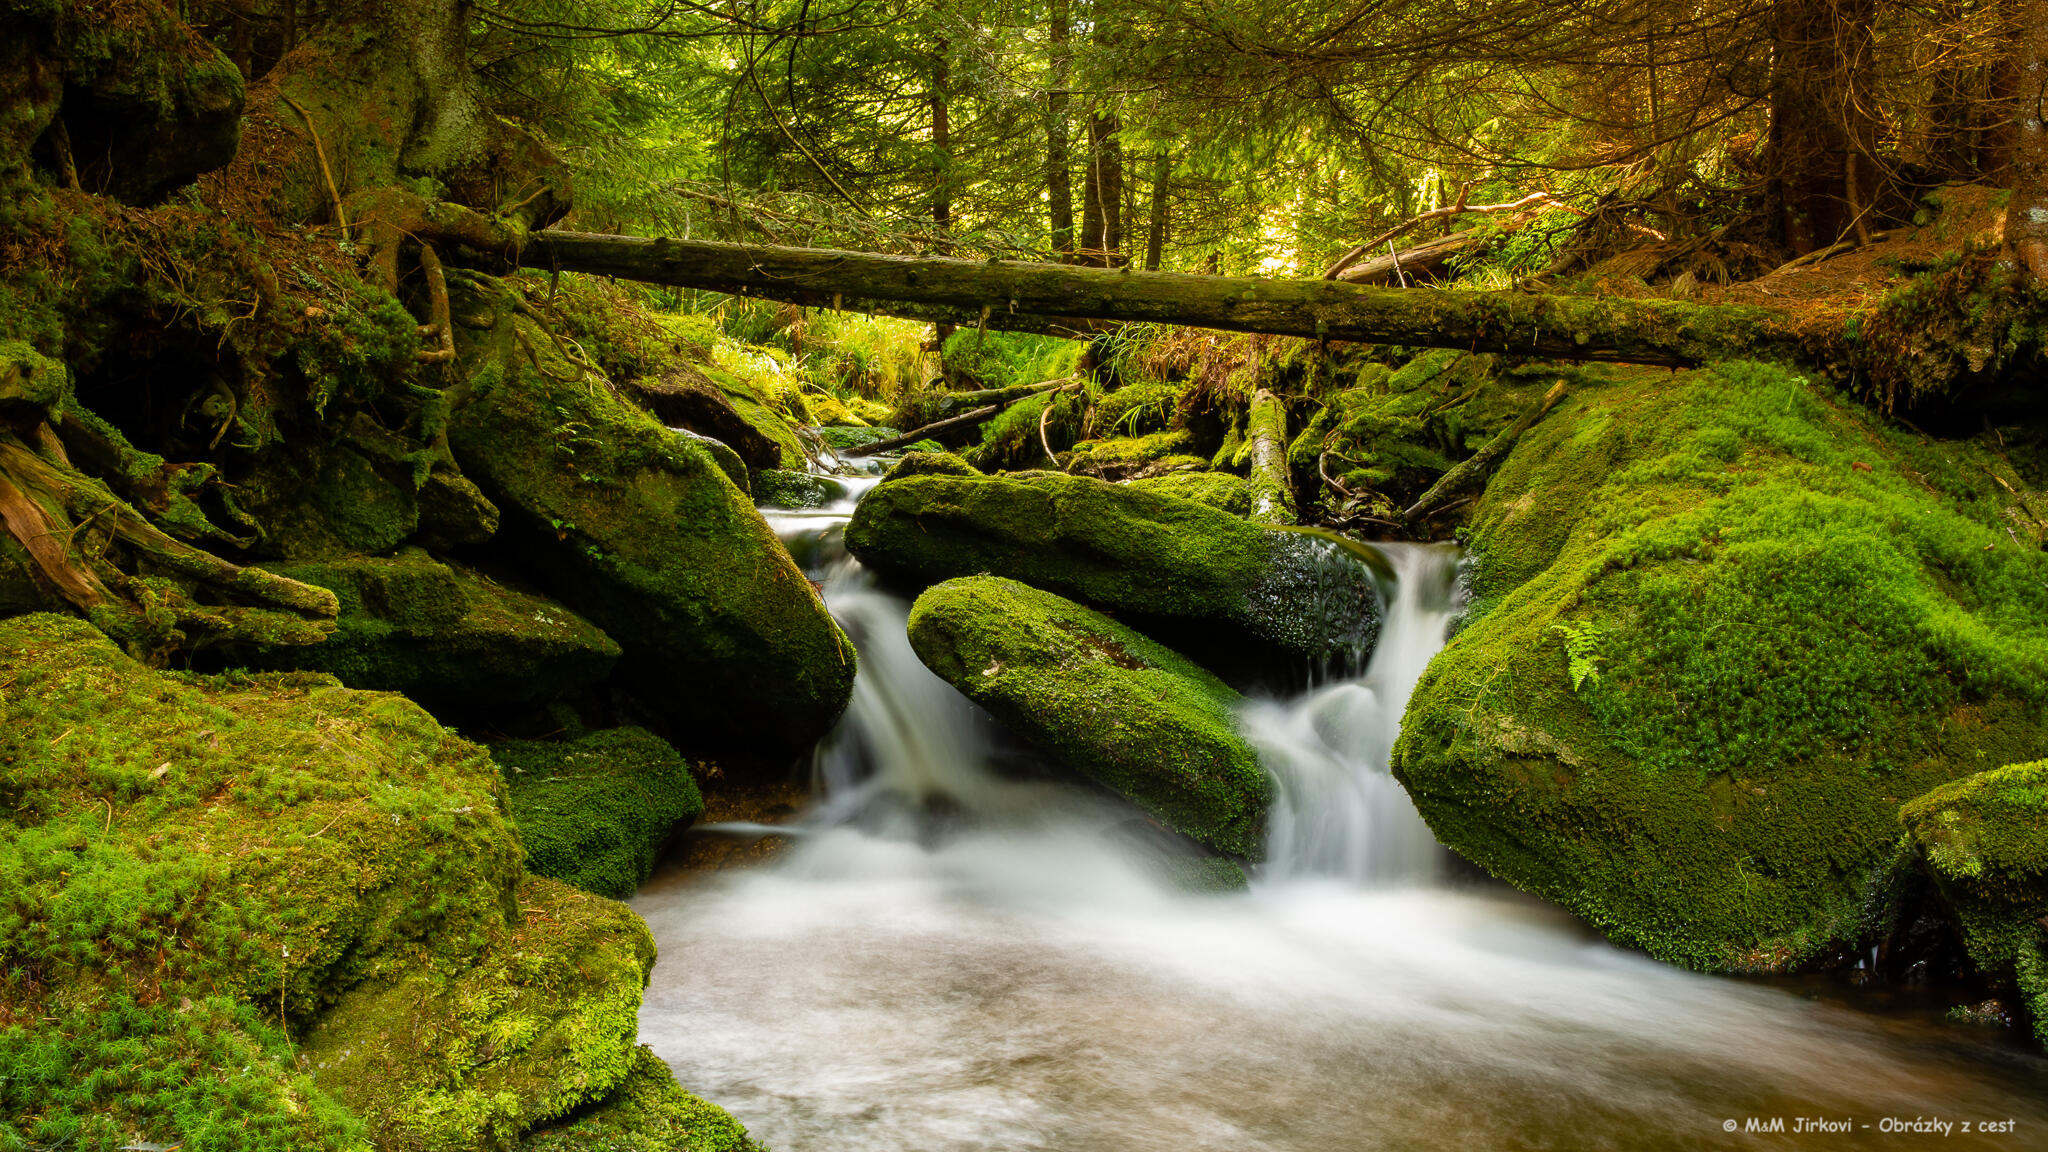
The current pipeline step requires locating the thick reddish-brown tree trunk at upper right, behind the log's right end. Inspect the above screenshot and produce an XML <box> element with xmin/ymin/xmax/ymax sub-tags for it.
<box><xmin>1769</xmin><ymin>0</ymin><xmax>1878</xmax><ymax>254</ymax></box>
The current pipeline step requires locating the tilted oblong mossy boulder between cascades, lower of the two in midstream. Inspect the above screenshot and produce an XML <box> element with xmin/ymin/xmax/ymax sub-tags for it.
<box><xmin>909</xmin><ymin>576</ymin><xmax>1272</xmax><ymax>857</ymax></box>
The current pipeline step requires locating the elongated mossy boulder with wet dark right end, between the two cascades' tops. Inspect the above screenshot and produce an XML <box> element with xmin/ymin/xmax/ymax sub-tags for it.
<box><xmin>846</xmin><ymin>471</ymin><xmax>1378</xmax><ymax>662</ymax></box>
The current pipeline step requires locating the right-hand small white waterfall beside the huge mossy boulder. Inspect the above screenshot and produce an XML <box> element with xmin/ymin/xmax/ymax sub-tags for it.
<box><xmin>1243</xmin><ymin>543</ymin><xmax>1460</xmax><ymax>883</ymax></box>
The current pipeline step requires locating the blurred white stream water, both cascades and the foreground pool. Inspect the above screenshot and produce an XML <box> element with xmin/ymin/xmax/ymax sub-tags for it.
<box><xmin>635</xmin><ymin>479</ymin><xmax>2048</xmax><ymax>1152</ymax></box>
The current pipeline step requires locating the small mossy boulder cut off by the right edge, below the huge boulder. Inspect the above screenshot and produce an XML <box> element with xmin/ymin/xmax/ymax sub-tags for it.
<box><xmin>1898</xmin><ymin>760</ymin><xmax>2048</xmax><ymax>1045</ymax></box>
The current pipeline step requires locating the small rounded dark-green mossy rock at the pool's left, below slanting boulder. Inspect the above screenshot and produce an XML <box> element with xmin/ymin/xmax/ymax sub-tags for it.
<box><xmin>492</xmin><ymin>728</ymin><xmax>705</xmax><ymax>900</ymax></box>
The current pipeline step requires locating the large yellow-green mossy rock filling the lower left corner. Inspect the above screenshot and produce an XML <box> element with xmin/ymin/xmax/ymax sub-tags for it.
<box><xmin>0</xmin><ymin>615</ymin><xmax>524</xmax><ymax>1150</ymax></box>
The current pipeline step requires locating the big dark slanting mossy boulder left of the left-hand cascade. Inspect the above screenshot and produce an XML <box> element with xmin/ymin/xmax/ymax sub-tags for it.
<box><xmin>449</xmin><ymin>281</ymin><xmax>854</xmax><ymax>760</ymax></box>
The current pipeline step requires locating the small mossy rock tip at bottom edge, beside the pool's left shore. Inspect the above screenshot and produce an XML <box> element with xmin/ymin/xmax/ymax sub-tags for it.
<box><xmin>520</xmin><ymin>1045</ymin><xmax>764</xmax><ymax>1152</ymax></box>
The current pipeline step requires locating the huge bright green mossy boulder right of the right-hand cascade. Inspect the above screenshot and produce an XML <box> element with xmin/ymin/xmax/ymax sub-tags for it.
<box><xmin>1395</xmin><ymin>365</ymin><xmax>2048</xmax><ymax>970</ymax></box>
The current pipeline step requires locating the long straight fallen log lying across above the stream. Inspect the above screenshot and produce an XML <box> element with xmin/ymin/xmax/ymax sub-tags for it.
<box><xmin>520</xmin><ymin>232</ymin><xmax>1796</xmax><ymax>367</ymax></box>
